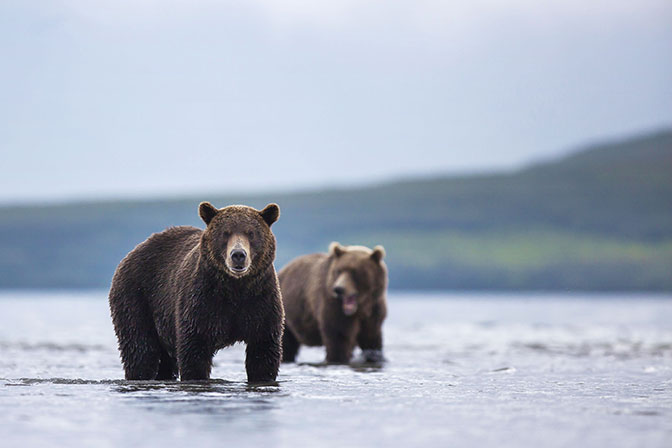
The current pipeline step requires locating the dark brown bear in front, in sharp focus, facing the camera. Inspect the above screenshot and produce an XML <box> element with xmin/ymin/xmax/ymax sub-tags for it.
<box><xmin>110</xmin><ymin>202</ymin><xmax>284</xmax><ymax>382</ymax></box>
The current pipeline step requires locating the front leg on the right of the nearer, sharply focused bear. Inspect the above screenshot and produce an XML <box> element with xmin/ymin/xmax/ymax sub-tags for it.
<box><xmin>245</xmin><ymin>333</ymin><xmax>282</xmax><ymax>383</ymax></box>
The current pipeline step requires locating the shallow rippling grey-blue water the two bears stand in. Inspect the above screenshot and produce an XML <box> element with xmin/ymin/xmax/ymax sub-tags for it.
<box><xmin>0</xmin><ymin>291</ymin><xmax>672</xmax><ymax>447</ymax></box>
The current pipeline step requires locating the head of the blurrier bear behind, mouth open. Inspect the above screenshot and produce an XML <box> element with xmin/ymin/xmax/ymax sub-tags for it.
<box><xmin>327</xmin><ymin>242</ymin><xmax>387</xmax><ymax>316</ymax></box>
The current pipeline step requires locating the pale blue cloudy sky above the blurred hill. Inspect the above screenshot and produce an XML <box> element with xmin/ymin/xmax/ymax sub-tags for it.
<box><xmin>0</xmin><ymin>0</ymin><xmax>672</xmax><ymax>203</ymax></box>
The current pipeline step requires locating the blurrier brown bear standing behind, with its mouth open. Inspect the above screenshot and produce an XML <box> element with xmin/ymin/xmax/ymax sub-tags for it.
<box><xmin>278</xmin><ymin>243</ymin><xmax>387</xmax><ymax>364</ymax></box>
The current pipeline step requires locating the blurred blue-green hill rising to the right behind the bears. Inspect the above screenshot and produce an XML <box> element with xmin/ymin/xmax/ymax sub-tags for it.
<box><xmin>0</xmin><ymin>130</ymin><xmax>672</xmax><ymax>291</ymax></box>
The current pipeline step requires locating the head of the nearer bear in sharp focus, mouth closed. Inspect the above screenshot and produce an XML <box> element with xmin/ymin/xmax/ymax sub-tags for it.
<box><xmin>198</xmin><ymin>202</ymin><xmax>280</xmax><ymax>278</ymax></box>
